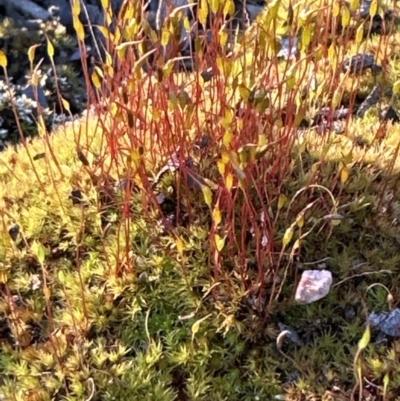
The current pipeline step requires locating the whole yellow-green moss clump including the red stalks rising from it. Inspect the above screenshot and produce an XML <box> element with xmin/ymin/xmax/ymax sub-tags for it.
<box><xmin>0</xmin><ymin>2</ymin><xmax>400</xmax><ymax>401</ymax></box>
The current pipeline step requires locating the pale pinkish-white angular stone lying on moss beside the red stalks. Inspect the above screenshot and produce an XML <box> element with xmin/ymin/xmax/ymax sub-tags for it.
<box><xmin>295</xmin><ymin>270</ymin><xmax>332</xmax><ymax>304</ymax></box>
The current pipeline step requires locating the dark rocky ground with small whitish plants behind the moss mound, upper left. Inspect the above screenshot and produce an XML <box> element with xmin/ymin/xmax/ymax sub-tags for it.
<box><xmin>0</xmin><ymin>0</ymin><xmax>264</xmax><ymax>149</ymax></box>
